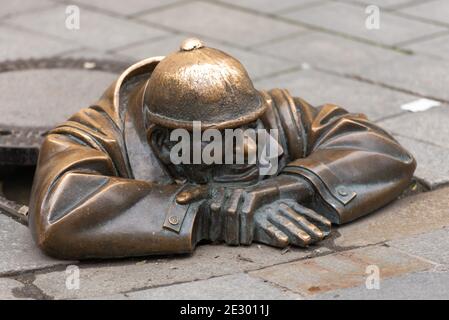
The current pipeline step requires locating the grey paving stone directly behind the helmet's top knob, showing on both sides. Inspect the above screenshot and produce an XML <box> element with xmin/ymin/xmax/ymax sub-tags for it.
<box><xmin>117</xmin><ymin>36</ymin><xmax>298</xmax><ymax>79</ymax></box>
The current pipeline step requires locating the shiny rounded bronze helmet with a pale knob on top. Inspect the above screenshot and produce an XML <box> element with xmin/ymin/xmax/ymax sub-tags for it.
<box><xmin>144</xmin><ymin>38</ymin><xmax>266</xmax><ymax>129</ymax></box>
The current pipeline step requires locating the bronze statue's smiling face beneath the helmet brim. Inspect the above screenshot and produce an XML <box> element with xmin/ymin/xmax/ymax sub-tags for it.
<box><xmin>150</xmin><ymin>121</ymin><xmax>262</xmax><ymax>184</ymax></box>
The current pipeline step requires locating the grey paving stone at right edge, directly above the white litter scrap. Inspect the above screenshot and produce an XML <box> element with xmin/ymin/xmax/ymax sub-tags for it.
<box><xmin>358</xmin><ymin>55</ymin><xmax>449</xmax><ymax>101</ymax></box>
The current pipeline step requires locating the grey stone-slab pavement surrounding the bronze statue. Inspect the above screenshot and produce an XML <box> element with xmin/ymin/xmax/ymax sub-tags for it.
<box><xmin>0</xmin><ymin>0</ymin><xmax>449</xmax><ymax>299</ymax></box>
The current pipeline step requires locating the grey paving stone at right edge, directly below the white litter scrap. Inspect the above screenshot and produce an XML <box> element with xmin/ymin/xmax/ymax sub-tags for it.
<box><xmin>380</xmin><ymin>105</ymin><xmax>449</xmax><ymax>148</ymax></box>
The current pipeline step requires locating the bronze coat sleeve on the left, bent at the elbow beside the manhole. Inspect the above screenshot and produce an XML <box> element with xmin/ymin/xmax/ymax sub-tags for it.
<box><xmin>29</xmin><ymin>107</ymin><xmax>203</xmax><ymax>259</ymax></box>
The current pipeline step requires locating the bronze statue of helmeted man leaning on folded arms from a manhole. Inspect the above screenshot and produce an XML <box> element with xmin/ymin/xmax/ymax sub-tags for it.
<box><xmin>29</xmin><ymin>39</ymin><xmax>416</xmax><ymax>259</ymax></box>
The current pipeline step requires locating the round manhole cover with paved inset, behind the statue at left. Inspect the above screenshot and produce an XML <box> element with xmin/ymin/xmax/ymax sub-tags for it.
<box><xmin>0</xmin><ymin>58</ymin><xmax>130</xmax><ymax>223</ymax></box>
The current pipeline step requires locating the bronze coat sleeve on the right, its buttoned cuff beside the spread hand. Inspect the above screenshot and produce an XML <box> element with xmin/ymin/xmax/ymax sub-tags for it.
<box><xmin>276</xmin><ymin>91</ymin><xmax>416</xmax><ymax>224</ymax></box>
